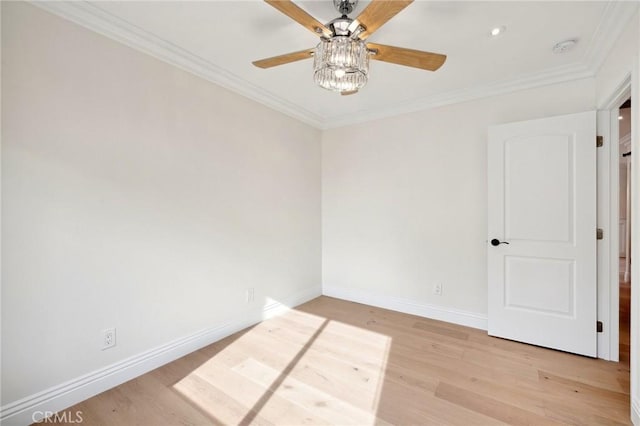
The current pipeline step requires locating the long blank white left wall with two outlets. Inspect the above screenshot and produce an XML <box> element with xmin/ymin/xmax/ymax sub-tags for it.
<box><xmin>2</xmin><ymin>2</ymin><xmax>321</xmax><ymax>410</ymax></box>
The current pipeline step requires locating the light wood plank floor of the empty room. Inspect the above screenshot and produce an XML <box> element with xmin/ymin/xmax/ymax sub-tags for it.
<box><xmin>43</xmin><ymin>297</ymin><xmax>630</xmax><ymax>425</ymax></box>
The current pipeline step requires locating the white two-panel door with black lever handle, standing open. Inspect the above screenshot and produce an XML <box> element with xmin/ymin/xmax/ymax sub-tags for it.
<box><xmin>487</xmin><ymin>112</ymin><xmax>597</xmax><ymax>357</ymax></box>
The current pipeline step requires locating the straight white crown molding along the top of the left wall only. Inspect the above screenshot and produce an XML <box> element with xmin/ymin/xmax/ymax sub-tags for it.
<box><xmin>28</xmin><ymin>0</ymin><xmax>323</xmax><ymax>128</ymax></box>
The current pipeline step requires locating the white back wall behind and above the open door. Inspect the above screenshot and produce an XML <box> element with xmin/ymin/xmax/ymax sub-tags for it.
<box><xmin>322</xmin><ymin>79</ymin><xmax>595</xmax><ymax>326</ymax></box>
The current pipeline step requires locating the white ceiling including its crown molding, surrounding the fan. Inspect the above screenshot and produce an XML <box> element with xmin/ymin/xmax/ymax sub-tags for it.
<box><xmin>35</xmin><ymin>0</ymin><xmax>638</xmax><ymax>128</ymax></box>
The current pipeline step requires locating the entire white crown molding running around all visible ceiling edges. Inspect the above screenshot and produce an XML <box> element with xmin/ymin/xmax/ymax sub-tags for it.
<box><xmin>28</xmin><ymin>0</ymin><xmax>638</xmax><ymax>130</ymax></box>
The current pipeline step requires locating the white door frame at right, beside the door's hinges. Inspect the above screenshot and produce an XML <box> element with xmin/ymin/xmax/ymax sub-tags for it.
<box><xmin>596</xmin><ymin>73</ymin><xmax>631</xmax><ymax>362</ymax></box>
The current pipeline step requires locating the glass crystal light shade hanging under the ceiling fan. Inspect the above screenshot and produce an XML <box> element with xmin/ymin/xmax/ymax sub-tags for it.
<box><xmin>313</xmin><ymin>36</ymin><xmax>369</xmax><ymax>92</ymax></box>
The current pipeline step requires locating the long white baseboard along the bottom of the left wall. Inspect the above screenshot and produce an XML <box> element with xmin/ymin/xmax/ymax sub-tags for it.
<box><xmin>0</xmin><ymin>287</ymin><xmax>321</xmax><ymax>426</ymax></box>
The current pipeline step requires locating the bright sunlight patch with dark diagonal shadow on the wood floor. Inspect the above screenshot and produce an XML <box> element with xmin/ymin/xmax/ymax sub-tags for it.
<box><xmin>173</xmin><ymin>309</ymin><xmax>391</xmax><ymax>425</ymax></box>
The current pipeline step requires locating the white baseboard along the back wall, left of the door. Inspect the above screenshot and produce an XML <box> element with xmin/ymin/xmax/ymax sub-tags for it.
<box><xmin>322</xmin><ymin>285</ymin><xmax>487</xmax><ymax>330</ymax></box>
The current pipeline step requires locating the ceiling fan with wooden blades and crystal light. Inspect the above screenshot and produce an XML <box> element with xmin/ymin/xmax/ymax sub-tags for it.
<box><xmin>253</xmin><ymin>0</ymin><xmax>447</xmax><ymax>95</ymax></box>
